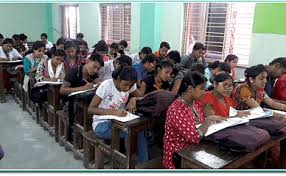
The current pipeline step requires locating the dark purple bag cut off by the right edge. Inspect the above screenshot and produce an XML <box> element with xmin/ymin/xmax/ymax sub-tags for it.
<box><xmin>249</xmin><ymin>117</ymin><xmax>286</xmax><ymax>136</ymax></box>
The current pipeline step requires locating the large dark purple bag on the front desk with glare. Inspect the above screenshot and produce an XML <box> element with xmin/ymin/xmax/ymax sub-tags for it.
<box><xmin>206</xmin><ymin>124</ymin><xmax>270</xmax><ymax>152</ymax></box>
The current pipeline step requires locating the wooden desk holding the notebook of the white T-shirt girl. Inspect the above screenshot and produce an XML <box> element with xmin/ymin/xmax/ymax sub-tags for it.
<box><xmin>111</xmin><ymin>117</ymin><xmax>154</xmax><ymax>169</ymax></box>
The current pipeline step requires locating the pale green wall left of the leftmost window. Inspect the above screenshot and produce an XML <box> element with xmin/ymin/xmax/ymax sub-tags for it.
<box><xmin>0</xmin><ymin>3</ymin><xmax>52</xmax><ymax>41</ymax></box>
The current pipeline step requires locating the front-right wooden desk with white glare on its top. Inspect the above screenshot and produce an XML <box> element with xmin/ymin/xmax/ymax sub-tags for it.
<box><xmin>178</xmin><ymin>135</ymin><xmax>286</xmax><ymax>169</ymax></box>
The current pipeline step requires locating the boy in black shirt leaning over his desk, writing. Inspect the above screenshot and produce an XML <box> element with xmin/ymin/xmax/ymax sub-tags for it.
<box><xmin>60</xmin><ymin>53</ymin><xmax>104</xmax><ymax>142</ymax></box>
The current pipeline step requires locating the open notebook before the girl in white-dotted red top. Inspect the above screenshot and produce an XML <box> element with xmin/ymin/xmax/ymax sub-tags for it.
<box><xmin>197</xmin><ymin>117</ymin><xmax>249</xmax><ymax>136</ymax></box>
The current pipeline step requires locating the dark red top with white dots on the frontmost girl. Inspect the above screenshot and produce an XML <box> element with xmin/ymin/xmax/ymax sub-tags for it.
<box><xmin>163</xmin><ymin>99</ymin><xmax>204</xmax><ymax>169</ymax></box>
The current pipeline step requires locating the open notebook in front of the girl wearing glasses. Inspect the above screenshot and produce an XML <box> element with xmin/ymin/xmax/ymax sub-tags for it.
<box><xmin>229</xmin><ymin>107</ymin><xmax>273</xmax><ymax>120</ymax></box>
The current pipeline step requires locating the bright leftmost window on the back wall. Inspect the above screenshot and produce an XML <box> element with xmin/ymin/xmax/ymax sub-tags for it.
<box><xmin>61</xmin><ymin>5</ymin><xmax>79</xmax><ymax>39</ymax></box>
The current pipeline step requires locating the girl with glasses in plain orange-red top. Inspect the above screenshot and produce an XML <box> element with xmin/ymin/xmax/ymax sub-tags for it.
<box><xmin>201</xmin><ymin>73</ymin><xmax>245</xmax><ymax>118</ymax></box>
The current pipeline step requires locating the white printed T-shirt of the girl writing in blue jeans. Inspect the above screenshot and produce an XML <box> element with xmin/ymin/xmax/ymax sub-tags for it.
<box><xmin>92</xmin><ymin>79</ymin><xmax>137</xmax><ymax>130</ymax></box>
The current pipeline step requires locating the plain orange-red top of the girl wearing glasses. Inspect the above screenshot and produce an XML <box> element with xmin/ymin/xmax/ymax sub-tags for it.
<box><xmin>201</xmin><ymin>92</ymin><xmax>236</xmax><ymax>117</ymax></box>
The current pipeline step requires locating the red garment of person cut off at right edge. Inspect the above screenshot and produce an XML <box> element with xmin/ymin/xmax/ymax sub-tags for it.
<box><xmin>272</xmin><ymin>74</ymin><xmax>286</xmax><ymax>102</ymax></box>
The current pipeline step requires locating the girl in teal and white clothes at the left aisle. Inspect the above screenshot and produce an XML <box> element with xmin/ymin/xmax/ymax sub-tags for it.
<box><xmin>23</xmin><ymin>41</ymin><xmax>48</xmax><ymax>92</ymax></box>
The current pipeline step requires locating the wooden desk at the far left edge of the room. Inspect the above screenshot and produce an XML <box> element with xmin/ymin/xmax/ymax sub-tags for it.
<box><xmin>0</xmin><ymin>60</ymin><xmax>22</xmax><ymax>103</ymax></box>
